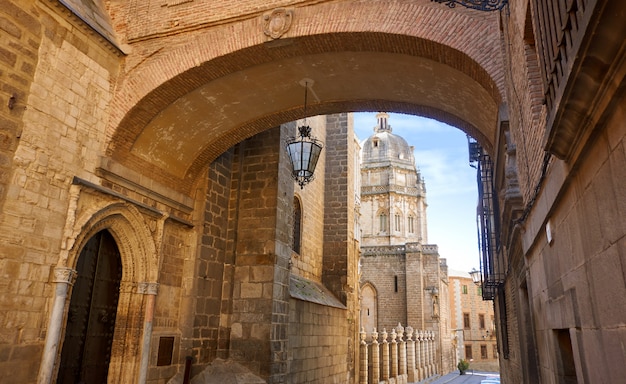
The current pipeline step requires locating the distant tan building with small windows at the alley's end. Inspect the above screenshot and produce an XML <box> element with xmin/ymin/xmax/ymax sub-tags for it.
<box><xmin>448</xmin><ymin>270</ymin><xmax>499</xmax><ymax>372</ymax></box>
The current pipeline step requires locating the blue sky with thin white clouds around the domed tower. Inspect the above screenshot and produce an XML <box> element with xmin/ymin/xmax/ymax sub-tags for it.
<box><xmin>354</xmin><ymin>112</ymin><xmax>479</xmax><ymax>272</ymax></box>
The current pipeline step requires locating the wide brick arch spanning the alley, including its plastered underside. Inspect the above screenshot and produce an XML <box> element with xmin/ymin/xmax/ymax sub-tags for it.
<box><xmin>107</xmin><ymin>5</ymin><xmax>502</xmax><ymax>192</ymax></box>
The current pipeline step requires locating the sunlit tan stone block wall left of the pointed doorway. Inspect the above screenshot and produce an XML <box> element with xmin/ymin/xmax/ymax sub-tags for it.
<box><xmin>0</xmin><ymin>1</ymin><xmax>118</xmax><ymax>382</ymax></box>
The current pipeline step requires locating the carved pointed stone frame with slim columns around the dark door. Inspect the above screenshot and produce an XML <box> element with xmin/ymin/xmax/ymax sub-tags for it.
<box><xmin>40</xmin><ymin>195</ymin><xmax>165</xmax><ymax>382</ymax></box>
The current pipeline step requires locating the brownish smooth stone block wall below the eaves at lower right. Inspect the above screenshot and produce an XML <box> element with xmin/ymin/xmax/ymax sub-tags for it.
<box><xmin>516</xmin><ymin>96</ymin><xmax>626</xmax><ymax>382</ymax></box>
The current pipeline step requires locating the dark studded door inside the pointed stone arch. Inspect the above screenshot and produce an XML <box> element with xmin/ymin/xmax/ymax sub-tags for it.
<box><xmin>57</xmin><ymin>230</ymin><xmax>122</xmax><ymax>384</ymax></box>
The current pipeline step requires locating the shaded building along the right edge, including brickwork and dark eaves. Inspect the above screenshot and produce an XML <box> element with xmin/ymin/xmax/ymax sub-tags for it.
<box><xmin>496</xmin><ymin>1</ymin><xmax>626</xmax><ymax>382</ymax></box>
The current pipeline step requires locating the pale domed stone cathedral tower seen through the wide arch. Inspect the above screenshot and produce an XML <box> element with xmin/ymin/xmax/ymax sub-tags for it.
<box><xmin>360</xmin><ymin>112</ymin><xmax>452</xmax><ymax>373</ymax></box>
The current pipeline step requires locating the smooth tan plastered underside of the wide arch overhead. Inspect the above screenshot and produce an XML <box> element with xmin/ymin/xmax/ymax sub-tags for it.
<box><xmin>130</xmin><ymin>52</ymin><xmax>497</xmax><ymax>175</ymax></box>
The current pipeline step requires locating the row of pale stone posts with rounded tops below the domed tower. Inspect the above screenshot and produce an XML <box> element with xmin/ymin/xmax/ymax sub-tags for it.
<box><xmin>359</xmin><ymin>324</ymin><xmax>439</xmax><ymax>384</ymax></box>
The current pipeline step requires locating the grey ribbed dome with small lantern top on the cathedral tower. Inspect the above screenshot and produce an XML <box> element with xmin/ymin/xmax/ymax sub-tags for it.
<box><xmin>362</xmin><ymin>112</ymin><xmax>415</xmax><ymax>166</ymax></box>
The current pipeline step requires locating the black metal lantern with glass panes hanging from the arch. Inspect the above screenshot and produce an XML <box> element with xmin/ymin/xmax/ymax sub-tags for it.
<box><xmin>286</xmin><ymin>79</ymin><xmax>324</xmax><ymax>188</ymax></box>
